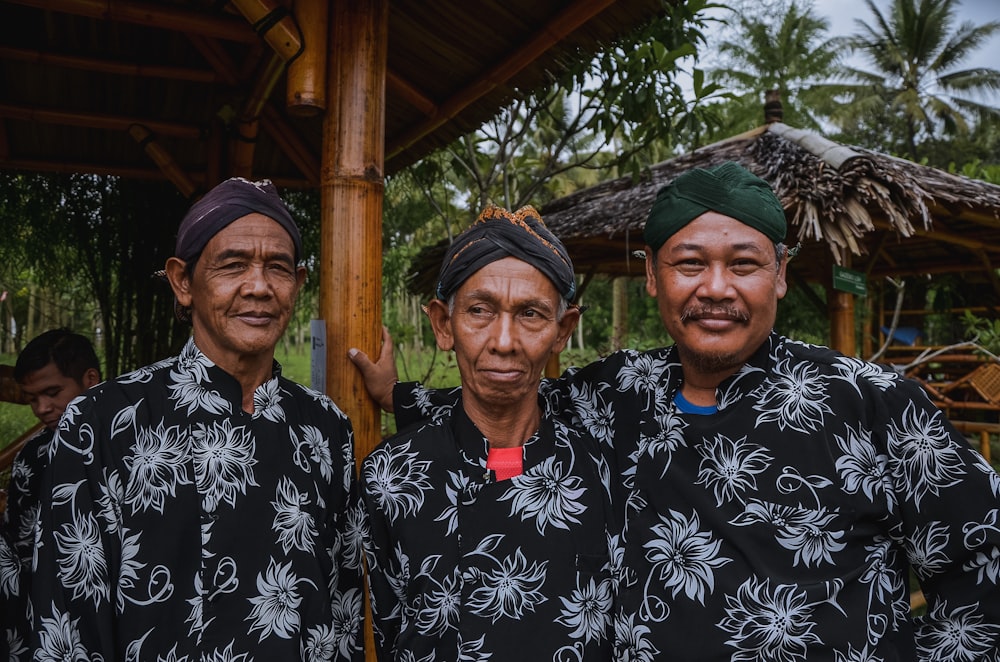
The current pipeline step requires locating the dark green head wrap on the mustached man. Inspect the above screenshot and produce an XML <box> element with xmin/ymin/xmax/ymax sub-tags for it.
<box><xmin>643</xmin><ymin>161</ymin><xmax>787</xmax><ymax>251</ymax></box>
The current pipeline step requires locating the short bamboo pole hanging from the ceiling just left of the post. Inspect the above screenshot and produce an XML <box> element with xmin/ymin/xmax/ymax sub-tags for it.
<box><xmin>285</xmin><ymin>0</ymin><xmax>330</xmax><ymax>116</ymax></box>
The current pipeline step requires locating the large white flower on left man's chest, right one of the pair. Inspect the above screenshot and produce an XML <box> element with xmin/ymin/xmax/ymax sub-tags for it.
<box><xmin>191</xmin><ymin>419</ymin><xmax>257</xmax><ymax>512</ymax></box>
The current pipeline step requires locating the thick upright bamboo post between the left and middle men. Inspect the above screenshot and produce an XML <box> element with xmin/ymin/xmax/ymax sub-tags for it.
<box><xmin>320</xmin><ymin>0</ymin><xmax>388</xmax><ymax>460</ymax></box>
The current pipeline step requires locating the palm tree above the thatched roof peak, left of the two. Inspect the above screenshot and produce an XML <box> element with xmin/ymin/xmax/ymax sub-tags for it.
<box><xmin>711</xmin><ymin>0</ymin><xmax>840</xmax><ymax>132</ymax></box>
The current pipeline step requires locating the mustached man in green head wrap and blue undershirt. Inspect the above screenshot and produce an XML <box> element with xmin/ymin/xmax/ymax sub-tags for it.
<box><xmin>354</xmin><ymin>163</ymin><xmax>1000</xmax><ymax>662</ymax></box>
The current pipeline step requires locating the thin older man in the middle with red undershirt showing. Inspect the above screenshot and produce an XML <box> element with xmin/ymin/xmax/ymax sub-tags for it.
<box><xmin>361</xmin><ymin>207</ymin><xmax>612</xmax><ymax>662</ymax></box>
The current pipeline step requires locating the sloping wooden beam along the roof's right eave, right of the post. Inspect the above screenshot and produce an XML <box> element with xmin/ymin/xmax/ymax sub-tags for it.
<box><xmin>385</xmin><ymin>0</ymin><xmax>614</xmax><ymax>161</ymax></box>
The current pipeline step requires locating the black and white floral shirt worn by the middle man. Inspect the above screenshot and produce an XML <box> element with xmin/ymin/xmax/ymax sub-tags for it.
<box><xmin>361</xmin><ymin>404</ymin><xmax>612</xmax><ymax>662</ymax></box>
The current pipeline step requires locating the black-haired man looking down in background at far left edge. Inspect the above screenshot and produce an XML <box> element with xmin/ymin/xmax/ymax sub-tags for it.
<box><xmin>0</xmin><ymin>328</ymin><xmax>101</xmax><ymax>659</ymax></box>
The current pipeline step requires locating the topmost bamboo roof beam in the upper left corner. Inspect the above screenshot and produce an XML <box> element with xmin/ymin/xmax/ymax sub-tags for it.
<box><xmin>5</xmin><ymin>0</ymin><xmax>258</xmax><ymax>44</ymax></box>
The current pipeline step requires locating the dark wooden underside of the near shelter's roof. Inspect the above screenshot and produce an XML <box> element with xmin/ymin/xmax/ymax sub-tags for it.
<box><xmin>0</xmin><ymin>0</ymin><xmax>662</xmax><ymax>193</ymax></box>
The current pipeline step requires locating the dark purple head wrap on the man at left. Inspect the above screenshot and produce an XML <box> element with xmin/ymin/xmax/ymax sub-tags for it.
<box><xmin>174</xmin><ymin>177</ymin><xmax>302</xmax><ymax>263</ymax></box>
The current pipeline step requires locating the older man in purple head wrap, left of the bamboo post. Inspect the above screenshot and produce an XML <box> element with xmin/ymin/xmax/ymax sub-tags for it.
<box><xmin>31</xmin><ymin>178</ymin><xmax>364</xmax><ymax>661</ymax></box>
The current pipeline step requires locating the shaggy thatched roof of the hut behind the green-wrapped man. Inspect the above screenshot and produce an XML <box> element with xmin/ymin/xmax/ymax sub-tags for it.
<box><xmin>413</xmin><ymin>122</ymin><xmax>1000</xmax><ymax>293</ymax></box>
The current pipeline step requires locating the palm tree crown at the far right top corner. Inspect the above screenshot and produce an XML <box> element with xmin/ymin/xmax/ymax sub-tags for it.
<box><xmin>833</xmin><ymin>0</ymin><xmax>1000</xmax><ymax>160</ymax></box>
